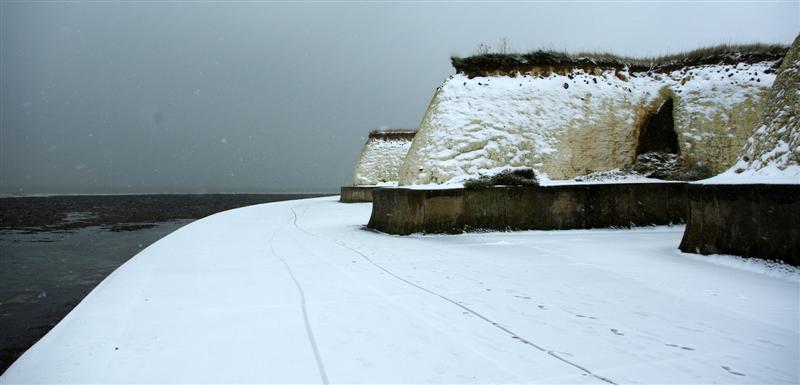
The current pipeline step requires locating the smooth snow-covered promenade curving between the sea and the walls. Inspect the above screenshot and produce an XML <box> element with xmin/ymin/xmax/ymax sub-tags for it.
<box><xmin>0</xmin><ymin>197</ymin><xmax>800</xmax><ymax>384</ymax></box>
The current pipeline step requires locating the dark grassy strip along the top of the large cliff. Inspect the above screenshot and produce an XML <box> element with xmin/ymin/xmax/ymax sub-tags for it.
<box><xmin>451</xmin><ymin>44</ymin><xmax>788</xmax><ymax>77</ymax></box>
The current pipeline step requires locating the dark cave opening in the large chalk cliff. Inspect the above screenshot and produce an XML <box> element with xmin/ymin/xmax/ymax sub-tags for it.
<box><xmin>636</xmin><ymin>99</ymin><xmax>680</xmax><ymax>155</ymax></box>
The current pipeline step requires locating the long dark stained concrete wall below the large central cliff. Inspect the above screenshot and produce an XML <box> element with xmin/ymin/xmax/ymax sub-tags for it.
<box><xmin>367</xmin><ymin>183</ymin><xmax>687</xmax><ymax>235</ymax></box>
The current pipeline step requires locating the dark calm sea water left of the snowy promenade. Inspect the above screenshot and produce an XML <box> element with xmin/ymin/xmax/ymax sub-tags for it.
<box><xmin>0</xmin><ymin>195</ymin><xmax>328</xmax><ymax>373</ymax></box>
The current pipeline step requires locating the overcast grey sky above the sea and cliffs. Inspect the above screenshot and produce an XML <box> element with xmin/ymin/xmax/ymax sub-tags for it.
<box><xmin>0</xmin><ymin>0</ymin><xmax>800</xmax><ymax>194</ymax></box>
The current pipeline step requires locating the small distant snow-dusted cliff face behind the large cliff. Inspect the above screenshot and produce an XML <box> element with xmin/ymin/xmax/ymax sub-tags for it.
<box><xmin>353</xmin><ymin>133</ymin><xmax>413</xmax><ymax>186</ymax></box>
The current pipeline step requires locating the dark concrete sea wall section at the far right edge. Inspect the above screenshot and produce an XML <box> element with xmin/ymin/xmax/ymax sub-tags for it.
<box><xmin>680</xmin><ymin>184</ymin><xmax>800</xmax><ymax>266</ymax></box>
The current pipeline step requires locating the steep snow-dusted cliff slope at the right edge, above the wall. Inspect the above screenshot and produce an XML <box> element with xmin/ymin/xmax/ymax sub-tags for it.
<box><xmin>704</xmin><ymin>35</ymin><xmax>800</xmax><ymax>184</ymax></box>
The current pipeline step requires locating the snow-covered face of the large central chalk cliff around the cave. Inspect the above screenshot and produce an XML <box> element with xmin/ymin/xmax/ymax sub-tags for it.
<box><xmin>400</xmin><ymin>62</ymin><xmax>775</xmax><ymax>184</ymax></box>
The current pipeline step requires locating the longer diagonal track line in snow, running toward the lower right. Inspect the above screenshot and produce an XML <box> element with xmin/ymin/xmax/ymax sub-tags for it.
<box><xmin>290</xmin><ymin>206</ymin><xmax>617</xmax><ymax>385</ymax></box>
